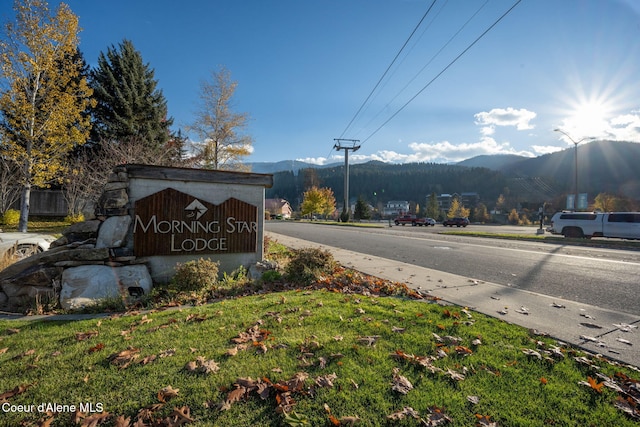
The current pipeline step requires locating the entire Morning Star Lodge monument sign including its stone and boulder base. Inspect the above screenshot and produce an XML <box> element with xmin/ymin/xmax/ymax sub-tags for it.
<box><xmin>0</xmin><ymin>165</ymin><xmax>273</xmax><ymax>311</ymax></box>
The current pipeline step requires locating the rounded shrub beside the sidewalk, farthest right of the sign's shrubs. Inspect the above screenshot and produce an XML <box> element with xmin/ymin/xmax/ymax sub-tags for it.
<box><xmin>285</xmin><ymin>248</ymin><xmax>337</xmax><ymax>284</ymax></box>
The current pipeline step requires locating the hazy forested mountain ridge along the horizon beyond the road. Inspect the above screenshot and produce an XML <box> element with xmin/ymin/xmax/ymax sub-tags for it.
<box><xmin>267</xmin><ymin>141</ymin><xmax>640</xmax><ymax>213</ymax></box>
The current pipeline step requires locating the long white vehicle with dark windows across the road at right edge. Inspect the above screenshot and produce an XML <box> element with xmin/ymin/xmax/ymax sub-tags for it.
<box><xmin>548</xmin><ymin>212</ymin><xmax>640</xmax><ymax>239</ymax></box>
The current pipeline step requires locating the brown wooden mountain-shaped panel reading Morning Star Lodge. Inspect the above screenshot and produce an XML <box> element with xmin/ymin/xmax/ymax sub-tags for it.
<box><xmin>133</xmin><ymin>188</ymin><xmax>258</xmax><ymax>256</ymax></box>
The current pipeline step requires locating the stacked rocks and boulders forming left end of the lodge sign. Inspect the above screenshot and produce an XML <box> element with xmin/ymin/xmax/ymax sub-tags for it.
<box><xmin>0</xmin><ymin>166</ymin><xmax>153</xmax><ymax>311</ymax></box>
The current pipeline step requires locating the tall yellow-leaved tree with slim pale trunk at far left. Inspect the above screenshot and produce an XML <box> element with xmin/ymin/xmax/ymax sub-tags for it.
<box><xmin>0</xmin><ymin>0</ymin><xmax>93</xmax><ymax>232</ymax></box>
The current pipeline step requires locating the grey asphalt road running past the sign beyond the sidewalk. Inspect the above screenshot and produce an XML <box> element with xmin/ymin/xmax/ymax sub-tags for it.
<box><xmin>266</xmin><ymin>221</ymin><xmax>640</xmax><ymax>314</ymax></box>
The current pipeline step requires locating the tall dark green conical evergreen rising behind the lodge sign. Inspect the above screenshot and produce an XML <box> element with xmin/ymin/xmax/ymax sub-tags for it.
<box><xmin>91</xmin><ymin>40</ymin><xmax>173</xmax><ymax>150</ymax></box>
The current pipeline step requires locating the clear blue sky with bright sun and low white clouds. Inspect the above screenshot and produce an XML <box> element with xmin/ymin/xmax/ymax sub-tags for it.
<box><xmin>0</xmin><ymin>0</ymin><xmax>640</xmax><ymax>163</ymax></box>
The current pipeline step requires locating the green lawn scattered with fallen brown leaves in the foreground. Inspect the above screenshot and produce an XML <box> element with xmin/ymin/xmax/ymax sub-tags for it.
<box><xmin>0</xmin><ymin>290</ymin><xmax>640</xmax><ymax>426</ymax></box>
